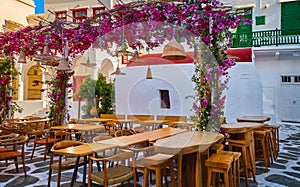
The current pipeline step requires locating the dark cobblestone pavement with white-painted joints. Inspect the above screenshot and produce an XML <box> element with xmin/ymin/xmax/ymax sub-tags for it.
<box><xmin>0</xmin><ymin>124</ymin><xmax>300</xmax><ymax>187</ymax></box>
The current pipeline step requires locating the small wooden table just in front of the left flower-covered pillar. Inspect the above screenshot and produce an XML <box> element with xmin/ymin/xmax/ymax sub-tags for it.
<box><xmin>51</xmin><ymin>124</ymin><xmax>104</xmax><ymax>143</ymax></box>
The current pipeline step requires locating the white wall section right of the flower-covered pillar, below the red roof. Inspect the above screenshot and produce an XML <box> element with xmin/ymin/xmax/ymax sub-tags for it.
<box><xmin>224</xmin><ymin>62</ymin><xmax>263</xmax><ymax>122</ymax></box>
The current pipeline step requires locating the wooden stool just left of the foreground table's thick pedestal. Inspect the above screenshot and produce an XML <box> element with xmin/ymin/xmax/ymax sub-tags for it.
<box><xmin>137</xmin><ymin>153</ymin><xmax>175</xmax><ymax>187</ymax></box>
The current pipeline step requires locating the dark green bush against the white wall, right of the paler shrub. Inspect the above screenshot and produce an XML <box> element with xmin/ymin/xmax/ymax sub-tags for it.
<box><xmin>95</xmin><ymin>73</ymin><xmax>113</xmax><ymax>115</ymax></box>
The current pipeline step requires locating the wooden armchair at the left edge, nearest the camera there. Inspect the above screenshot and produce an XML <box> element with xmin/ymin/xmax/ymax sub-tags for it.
<box><xmin>0</xmin><ymin>136</ymin><xmax>28</xmax><ymax>177</ymax></box>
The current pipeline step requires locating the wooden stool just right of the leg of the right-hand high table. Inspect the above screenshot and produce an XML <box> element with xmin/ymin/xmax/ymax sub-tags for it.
<box><xmin>254</xmin><ymin>128</ymin><xmax>272</xmax><ymax>171</ymax></box>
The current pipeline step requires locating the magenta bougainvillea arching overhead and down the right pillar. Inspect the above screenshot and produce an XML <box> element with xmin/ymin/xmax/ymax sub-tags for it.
<box><xmin>0</xmin><ymin>0</ymin><xmax>248</xmax><ymax>130</ymax></box>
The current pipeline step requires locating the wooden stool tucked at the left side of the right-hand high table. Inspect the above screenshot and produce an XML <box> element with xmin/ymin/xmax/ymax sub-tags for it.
<box><xmin>226</xmin><ymin>138</ymin><xmax>256</xmax><ymax>187</ymax></box>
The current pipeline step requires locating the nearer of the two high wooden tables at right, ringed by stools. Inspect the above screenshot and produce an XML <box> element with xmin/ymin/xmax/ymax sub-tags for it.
<box><xmin>221</xmin><ymin>122</ymin><xmax>265</xmax><ymax>174</ymax></box>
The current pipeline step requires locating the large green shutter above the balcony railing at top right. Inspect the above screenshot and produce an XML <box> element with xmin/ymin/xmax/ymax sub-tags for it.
<box><xmin>281</xmin><ymin>1</ymin><xmax>300</xmax><ymax>29</ymax></box>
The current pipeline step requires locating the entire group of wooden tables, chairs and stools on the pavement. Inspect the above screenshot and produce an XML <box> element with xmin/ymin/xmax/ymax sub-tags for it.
<box><xmin>0</xmin><ymin>114</ymin><xmax>290</xmax><ymax>187</ymax></box>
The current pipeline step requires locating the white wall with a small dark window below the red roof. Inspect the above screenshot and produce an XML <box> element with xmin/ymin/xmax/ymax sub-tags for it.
<box><xmin>115</xmin><ymin>64</ymin><xmax>194</xmax><ymax>116</ymax></box>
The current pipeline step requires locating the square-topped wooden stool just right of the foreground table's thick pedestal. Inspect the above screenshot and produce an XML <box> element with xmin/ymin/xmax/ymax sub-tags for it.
<box><xmin>205</xmin><ymin>153</ymin><xmax>233</xmax><ymax>187</ymax></box>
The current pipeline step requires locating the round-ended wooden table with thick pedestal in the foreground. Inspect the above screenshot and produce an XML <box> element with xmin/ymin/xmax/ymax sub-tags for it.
<box><xmin>154</xmin><ymin>131</ymin><xmax>224</xmax><ymax>187</ymax></box>
